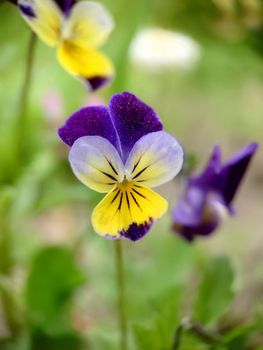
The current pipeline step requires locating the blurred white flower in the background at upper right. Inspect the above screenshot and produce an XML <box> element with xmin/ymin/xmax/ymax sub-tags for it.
<box><xmin>129</xmin><ymin>27</ymin><xmax>201</xmax><ymax>71</ymax></box>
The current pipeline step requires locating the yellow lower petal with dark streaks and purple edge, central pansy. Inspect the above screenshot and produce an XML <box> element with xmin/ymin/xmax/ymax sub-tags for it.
<box><xmin>92</xmin><ymin>181</ymin><xmax>168</xmax><ymax>241</ymax></box>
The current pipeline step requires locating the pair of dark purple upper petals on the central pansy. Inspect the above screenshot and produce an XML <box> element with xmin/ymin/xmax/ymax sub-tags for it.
<box><xmin>58</xmin><ymin>92</ymin><xmax>163</xmax><ymax>162</ymax></box>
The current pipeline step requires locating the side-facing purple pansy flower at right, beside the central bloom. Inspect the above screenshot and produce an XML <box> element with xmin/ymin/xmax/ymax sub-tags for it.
<box><xmin>173</xmin><ymin>143</ymin><xmax>258</xmax><ymax>241</ymax></box>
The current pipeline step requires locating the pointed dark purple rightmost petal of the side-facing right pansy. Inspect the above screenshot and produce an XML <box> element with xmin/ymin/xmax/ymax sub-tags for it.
<box><xmin>220</xmin><ymin>143</ymin><xmax>258</xmax><ymax>205</ymax></box>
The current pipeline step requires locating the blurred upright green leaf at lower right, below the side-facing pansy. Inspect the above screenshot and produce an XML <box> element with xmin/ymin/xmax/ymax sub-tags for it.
<box><xmin>195</xmin><ymin>257</ymin><xmax>234</xmax><ymax>324</ymax></box>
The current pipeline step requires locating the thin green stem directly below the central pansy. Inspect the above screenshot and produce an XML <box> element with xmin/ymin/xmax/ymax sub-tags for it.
<box><xmin>114</xmin><ymin>240</ymin><xmax>127</xmax><ymax>350</ymax></box>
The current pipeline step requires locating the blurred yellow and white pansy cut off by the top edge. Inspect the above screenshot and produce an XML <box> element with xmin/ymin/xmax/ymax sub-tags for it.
<box><xmin>17</xmin><ymin>0</ymin><xmax>114</xmax><ymax>90</ymax></box>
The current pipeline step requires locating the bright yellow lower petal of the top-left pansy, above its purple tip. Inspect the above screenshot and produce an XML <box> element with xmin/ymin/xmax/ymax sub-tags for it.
<box><xmin>57</xmin><ymin>41</ymin><xmax>114</xmax><ymax>79</ymax></box>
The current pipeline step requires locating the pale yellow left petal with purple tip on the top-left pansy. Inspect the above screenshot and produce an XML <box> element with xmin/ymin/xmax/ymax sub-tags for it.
<box><xmin>18</xmin><ymin>0</ymin><xmax>63</xmax><ymax>46</ymax></box>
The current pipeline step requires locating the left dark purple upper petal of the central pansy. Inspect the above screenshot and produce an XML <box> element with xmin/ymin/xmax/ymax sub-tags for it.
<box><xmin>58</xmin><ymin>106</ymin><xmax>117</xmax><ymax>147</ymax></box>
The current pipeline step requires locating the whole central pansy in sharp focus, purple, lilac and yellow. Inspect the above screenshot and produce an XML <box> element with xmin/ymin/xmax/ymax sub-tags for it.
<box><xmin>59</xmin><ymin>92</ymin><xmax>183</xmax><ymax>241</ymax></box>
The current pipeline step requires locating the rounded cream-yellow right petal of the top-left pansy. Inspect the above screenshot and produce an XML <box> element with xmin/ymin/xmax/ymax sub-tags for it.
<box><xmin>63</xmin><ymin>1</ymin><xmax>114</xmax><ymax>48</ymax></box>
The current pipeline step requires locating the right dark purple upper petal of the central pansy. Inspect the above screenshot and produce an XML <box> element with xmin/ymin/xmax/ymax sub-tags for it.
<box><xmin>109</xmin><ymin>92</ymin><xmax>163</xmax><ymax>161</ymax></box>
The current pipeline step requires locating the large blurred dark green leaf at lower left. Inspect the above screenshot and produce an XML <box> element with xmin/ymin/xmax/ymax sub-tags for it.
<box><xmin>26</xmin><ymin>246</ymin><xmax>85</xmax><ymax>335</ymax></box>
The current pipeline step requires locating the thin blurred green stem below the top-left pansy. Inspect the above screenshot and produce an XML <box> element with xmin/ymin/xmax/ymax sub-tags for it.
<box><xmin>17</xmin><ymin>32</ymin><xmax>37</xmax><ymax>155</ymax></box>
